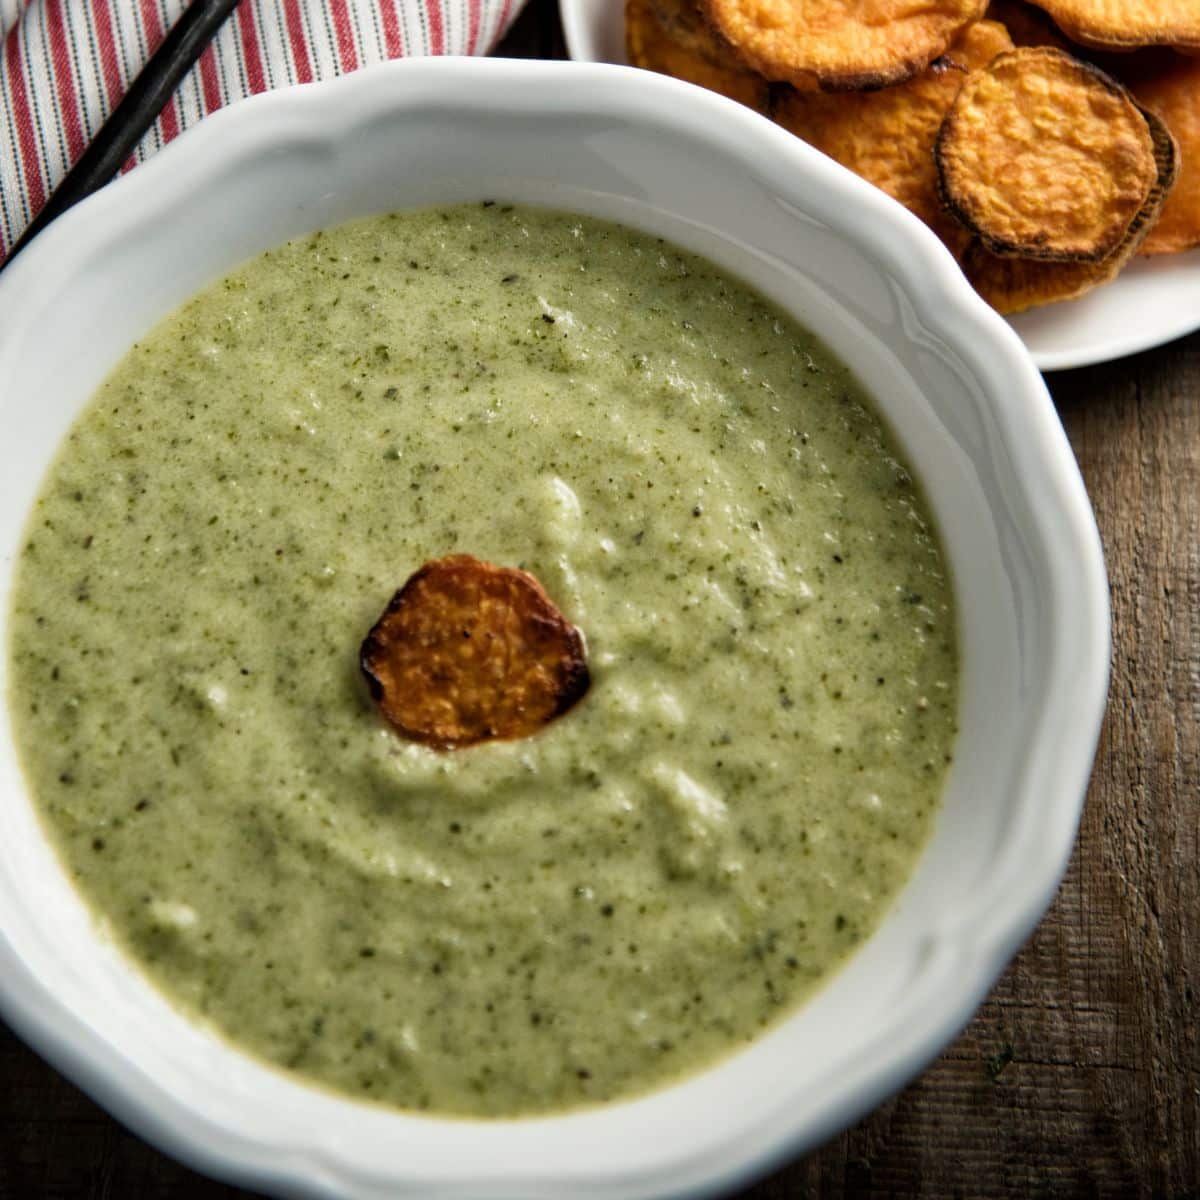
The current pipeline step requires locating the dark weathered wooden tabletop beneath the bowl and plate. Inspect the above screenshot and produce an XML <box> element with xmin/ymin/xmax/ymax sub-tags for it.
<box><xmin>0</xmin><ymin>0</ymin><xmax>1200</xmax><ymax>1200</ymax></box>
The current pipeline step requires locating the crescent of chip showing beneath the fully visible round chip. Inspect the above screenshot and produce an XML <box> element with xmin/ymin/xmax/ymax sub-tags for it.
<box><xmin>962</xmin><ymin>103</ymin><xmax>1178</xmax><ymax>314</ymax></box>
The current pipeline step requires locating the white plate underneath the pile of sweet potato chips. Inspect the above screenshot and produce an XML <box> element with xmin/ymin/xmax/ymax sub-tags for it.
<box><xmin>558</xmin><ymin>0</ymin><xmax>1200</xmax><ymax>371</ymax></box>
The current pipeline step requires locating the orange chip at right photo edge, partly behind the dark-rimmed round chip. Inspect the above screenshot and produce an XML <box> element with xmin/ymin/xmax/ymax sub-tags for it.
<box><xmin>1105</xmin><ymin>50</ymin><xmax>1200</xmax><ymax>254</ymax></box>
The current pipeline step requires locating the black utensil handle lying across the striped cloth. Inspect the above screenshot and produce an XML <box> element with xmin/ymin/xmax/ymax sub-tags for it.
<box><xmin>0</xmin><ymin>0</ymin><xmax>239</xmax><ymax>269</ymax></box>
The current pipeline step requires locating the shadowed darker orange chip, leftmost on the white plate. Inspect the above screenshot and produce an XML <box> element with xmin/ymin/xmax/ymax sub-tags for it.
<box><xmin>625</xmin><ymin>0</ymin><xmax>767</xmax><ymax>113</ymax></box>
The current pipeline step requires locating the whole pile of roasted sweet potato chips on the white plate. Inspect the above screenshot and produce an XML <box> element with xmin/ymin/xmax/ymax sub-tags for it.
<box><xmin>625</xmin><ymin>0</ymin><xmax>1200</xmax><ymax>313</ymax></box>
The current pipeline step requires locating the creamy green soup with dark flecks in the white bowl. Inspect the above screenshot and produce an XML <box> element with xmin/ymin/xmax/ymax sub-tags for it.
<box><xmin>7</xmin><ymin>203</ymin><xmax>958</xmax><ymax>1117</ymax></box>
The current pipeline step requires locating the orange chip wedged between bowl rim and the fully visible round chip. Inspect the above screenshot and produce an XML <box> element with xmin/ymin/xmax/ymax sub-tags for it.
<box><xmin>772</xmin><ymin>20</ymin><xmax>1013</xmax><ymax>251</ymax></box>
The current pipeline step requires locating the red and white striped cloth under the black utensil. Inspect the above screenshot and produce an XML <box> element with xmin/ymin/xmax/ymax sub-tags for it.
<box><xmin>0</xmin><ymin>0</ymin><xmax>521</xmax><ymax>262</ymax></box>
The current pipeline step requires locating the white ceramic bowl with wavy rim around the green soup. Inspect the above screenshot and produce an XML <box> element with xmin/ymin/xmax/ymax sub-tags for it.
<box><xmin>0</xmin><ymin>59</ymin><xmax>1109</xmax><ymax>1200</ymax></box>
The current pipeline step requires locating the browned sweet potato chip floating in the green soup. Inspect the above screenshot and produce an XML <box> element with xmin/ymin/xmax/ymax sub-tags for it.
<box><xmin>359</xmin><ymin>554</ymin><xmax>590</xmax><ymax>750</ymax></box>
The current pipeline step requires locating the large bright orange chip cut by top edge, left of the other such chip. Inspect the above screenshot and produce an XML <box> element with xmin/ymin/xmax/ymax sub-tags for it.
<box><xmin>703</xmin><ymin>0</ymin><xmax>988</xmax><ymax>91</ymax></box>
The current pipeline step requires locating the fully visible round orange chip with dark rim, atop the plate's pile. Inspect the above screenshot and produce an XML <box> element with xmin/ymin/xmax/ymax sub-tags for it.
<box><xmin>934</xmin><ymin>47</ymin><xmax>1158</xmax><ymax>262</ymax></box>
